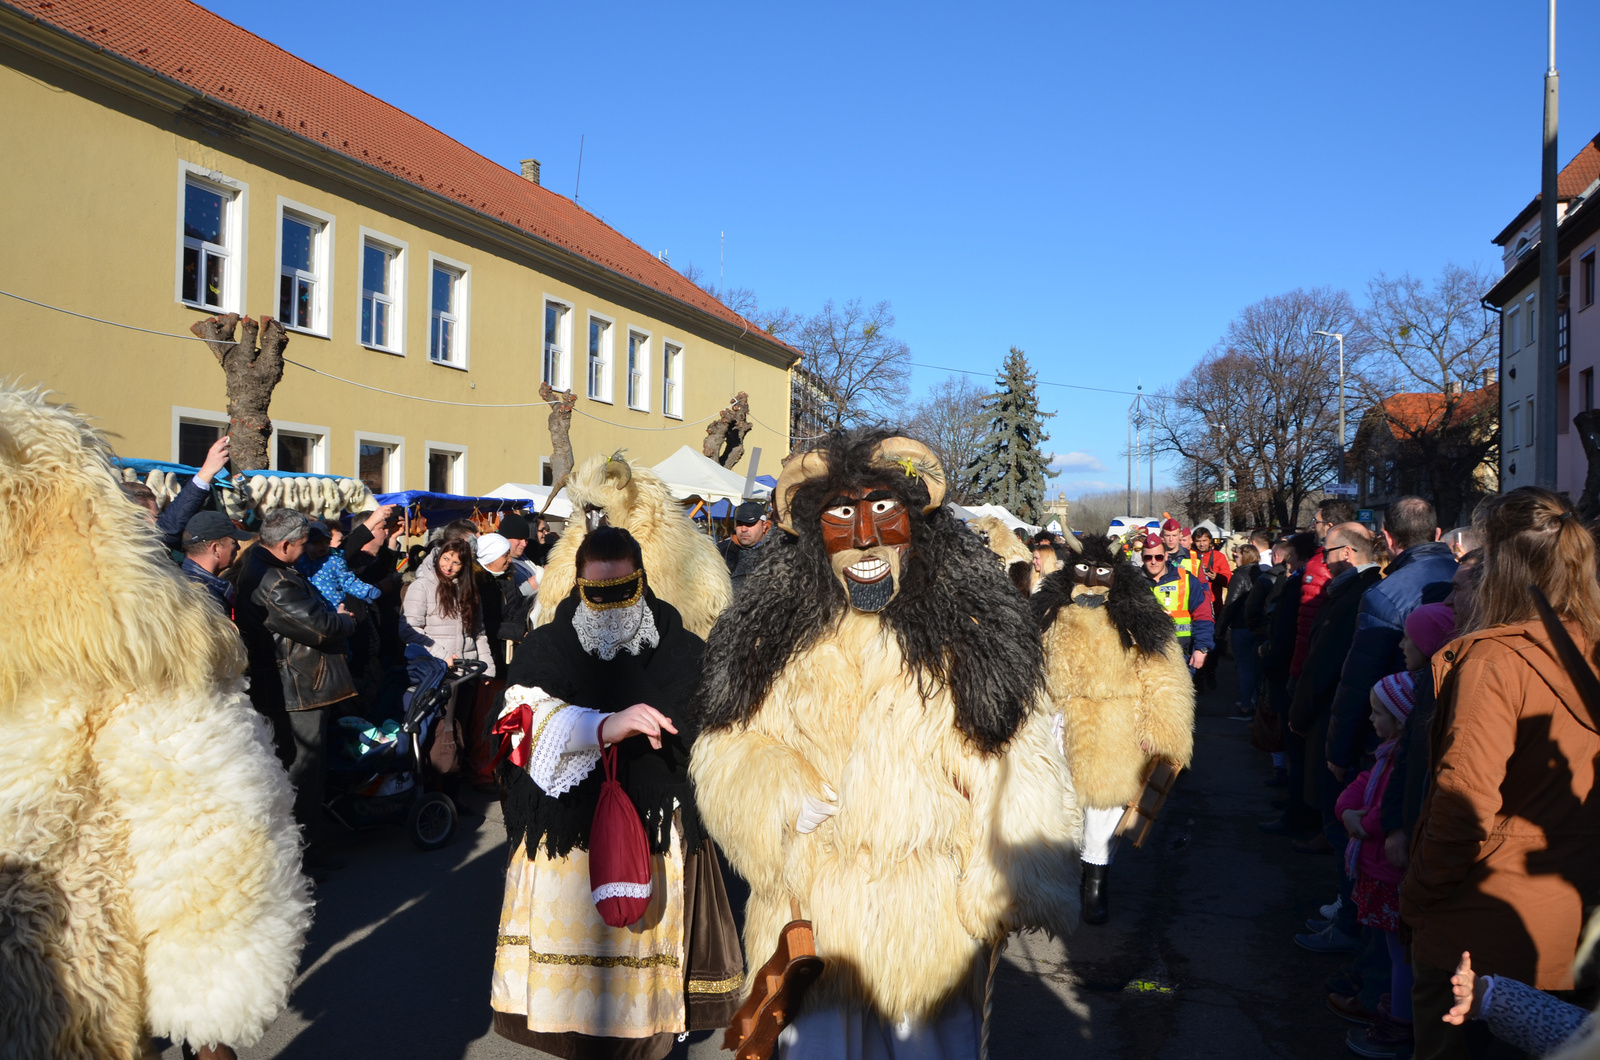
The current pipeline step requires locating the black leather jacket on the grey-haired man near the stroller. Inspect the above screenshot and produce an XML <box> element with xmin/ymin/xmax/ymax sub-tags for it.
<box><xmin>234</xmin><ymin>544</ymin><xmax>355</xmax><ymax>716</ymax></box>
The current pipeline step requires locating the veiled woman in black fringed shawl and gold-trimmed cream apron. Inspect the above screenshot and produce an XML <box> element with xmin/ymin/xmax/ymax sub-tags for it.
<box><xmin>491</xmin><ymin>527</ymin><xmax>744</xmax><ymax>1060</ymax></box>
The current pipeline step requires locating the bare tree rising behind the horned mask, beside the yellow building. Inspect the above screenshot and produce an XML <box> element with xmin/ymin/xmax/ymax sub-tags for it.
<box><xmin>797</xmin><ymin>298</ymin><xmax>910</xmax><ymax>431</ymax></box>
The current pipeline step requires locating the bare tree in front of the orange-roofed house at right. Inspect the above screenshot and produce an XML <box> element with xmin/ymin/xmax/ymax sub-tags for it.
<box><xmin>1355</xmin><ymin>264</ymin><xmax>1499</xmax><ymax>525</ymax></box>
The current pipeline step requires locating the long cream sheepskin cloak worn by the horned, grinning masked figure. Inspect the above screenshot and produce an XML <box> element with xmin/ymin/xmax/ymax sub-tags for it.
<box><xmin>690</xmin><ymin>614</ymin><xmax>1082</xmax><ymax>1022</ymax></box>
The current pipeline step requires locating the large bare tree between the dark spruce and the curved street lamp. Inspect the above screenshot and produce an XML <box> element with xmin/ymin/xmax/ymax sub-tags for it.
<box><xmin>1154</xmin><ymin>288</ymin><xmax>1363</xmax><ymax>527</ymax></box>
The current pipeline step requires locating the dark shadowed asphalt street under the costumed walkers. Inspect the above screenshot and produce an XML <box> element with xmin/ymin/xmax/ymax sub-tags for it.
<box><xmin>163</xmin><ymin>663</ymin><xmax>1347</xmax><ymax>1060</ymax></box>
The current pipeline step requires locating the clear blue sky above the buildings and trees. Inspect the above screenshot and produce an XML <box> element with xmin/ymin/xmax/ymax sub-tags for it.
<box><xmin>208</xmin><ymin>0</ymin><xmax>1600</xmax><ymax>493</ymax></box>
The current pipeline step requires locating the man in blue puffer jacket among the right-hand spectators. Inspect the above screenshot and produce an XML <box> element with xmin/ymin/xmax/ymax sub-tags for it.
<box><xmin>1328</xmin><ymin>496</ymin><xmax>1456</xmax><ymax>780</ymax></box>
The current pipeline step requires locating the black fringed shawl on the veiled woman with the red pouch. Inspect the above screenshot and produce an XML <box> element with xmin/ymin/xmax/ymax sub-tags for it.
<box><xmin>501</xmin><ymin>589</ymin><xmax>706</xmax><ymax>857</ymax></box>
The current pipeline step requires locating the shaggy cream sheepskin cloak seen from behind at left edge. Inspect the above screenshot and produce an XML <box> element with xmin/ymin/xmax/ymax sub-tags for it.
<box><xmin>0</xmin><ymin>387</ymin><xmax>310</xmax><ymax>1060</ymax></box>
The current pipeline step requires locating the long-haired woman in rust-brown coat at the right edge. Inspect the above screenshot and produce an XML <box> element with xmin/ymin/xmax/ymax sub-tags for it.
<box><xmin>1400</xmin><ymin>487</ymin><xmax>1600</xmax><ymax>1060</ymax></box>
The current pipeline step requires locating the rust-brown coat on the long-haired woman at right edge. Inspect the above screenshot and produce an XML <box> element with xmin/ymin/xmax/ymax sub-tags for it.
<box><xmin>1400</xmin><ymin>620</ymin><xmax>1600</xmax><ymax>990</ymax></box>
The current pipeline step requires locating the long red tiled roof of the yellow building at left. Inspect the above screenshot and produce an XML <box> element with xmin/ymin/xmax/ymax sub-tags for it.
<box><xmin>0</xmin><ymin>0</ymin><xmax>778</xmax><ymax>352</ymax></box>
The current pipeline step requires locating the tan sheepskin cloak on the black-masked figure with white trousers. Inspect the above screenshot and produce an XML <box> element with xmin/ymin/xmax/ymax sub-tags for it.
<box><xmin>1035</xmin><ymin>582</ymin><xmax>1195</xmax><ymax>809</ymax></box>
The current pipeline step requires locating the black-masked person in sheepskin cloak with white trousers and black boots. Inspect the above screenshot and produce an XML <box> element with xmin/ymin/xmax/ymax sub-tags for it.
<box><xmin>1034</xmin><ymin>533</ymin><xmax>1195</xmax><ymax>924</ymax></box>
